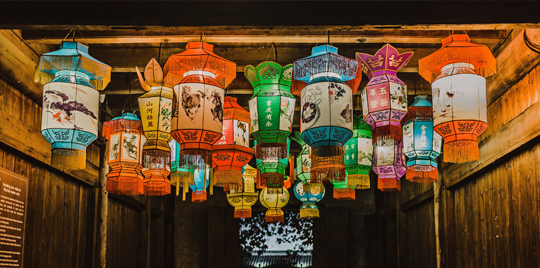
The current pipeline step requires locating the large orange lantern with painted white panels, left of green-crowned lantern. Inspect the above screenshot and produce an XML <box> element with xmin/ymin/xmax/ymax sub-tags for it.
<box><xmin>164</xmin><ymin>42</ymin><xmax>236</xmax><ymax>175</ymax></box>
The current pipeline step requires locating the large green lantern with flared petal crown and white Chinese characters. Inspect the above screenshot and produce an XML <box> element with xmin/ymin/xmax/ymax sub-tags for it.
<box><xmin>244</xmin><ymin>61</ymin><xmax>296</xmax><ymax>181</ymax></box>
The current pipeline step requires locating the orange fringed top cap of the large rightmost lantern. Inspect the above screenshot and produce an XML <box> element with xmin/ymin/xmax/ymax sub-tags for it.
<box><xmin>418</xmin><ymin>34</ymin><xmax>497</xmax><ymax>83</ymax></box>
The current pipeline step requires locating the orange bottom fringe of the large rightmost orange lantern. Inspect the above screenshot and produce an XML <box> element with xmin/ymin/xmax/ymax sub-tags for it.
<box><xmin>443</xmin><ymin>141</ymin><xmax>480</xmax><ymax>164</ymax></box>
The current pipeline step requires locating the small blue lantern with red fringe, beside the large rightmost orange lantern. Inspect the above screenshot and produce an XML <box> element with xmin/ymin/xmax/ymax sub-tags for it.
<box><xmin>403</xmin><ymin>96</ymin><xmax>442</xmax><ymax>183</ymax></box>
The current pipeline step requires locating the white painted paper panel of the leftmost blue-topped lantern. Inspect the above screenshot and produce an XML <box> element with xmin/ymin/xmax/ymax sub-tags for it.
<box><xmin>41</xmin><ymin>82</ymin><xmax>99</xmax><ymax>136</ymax></box>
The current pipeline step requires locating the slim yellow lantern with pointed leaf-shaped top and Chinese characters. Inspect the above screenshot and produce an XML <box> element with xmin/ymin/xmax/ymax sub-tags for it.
<box><xmin>135</xmin><ymin>58</ymin><xmax>173</xmax><ymax>157</ymax></box>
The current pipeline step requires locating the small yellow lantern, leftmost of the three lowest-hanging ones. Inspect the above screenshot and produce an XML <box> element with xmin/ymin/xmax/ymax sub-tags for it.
<box><xmin>227</xmin><ymin>165</ymin><xmax>259</xmax><ymax>219</ymax></box>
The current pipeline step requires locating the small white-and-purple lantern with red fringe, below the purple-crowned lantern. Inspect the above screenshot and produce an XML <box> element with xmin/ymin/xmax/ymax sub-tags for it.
<box><xmin>373</xmin><ymin>137</ymin><xmax>405</xmax><ymax>192</ymax></box>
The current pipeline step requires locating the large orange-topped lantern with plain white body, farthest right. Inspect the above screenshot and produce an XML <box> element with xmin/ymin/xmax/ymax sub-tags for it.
<box><xmin>418</xmin><ymin>34</ymin><xmax>496</xmax><ymax>163</ymax></box>
